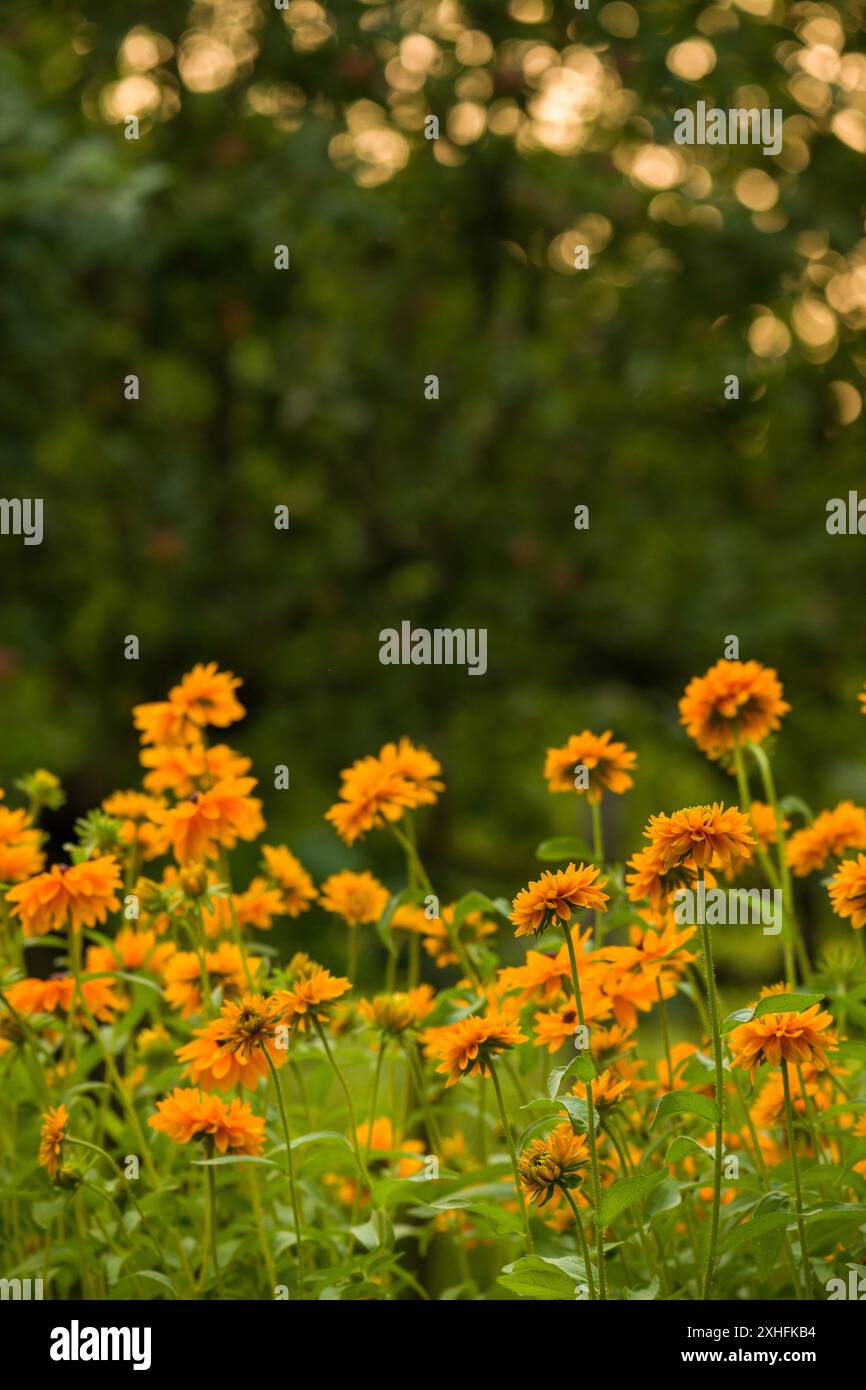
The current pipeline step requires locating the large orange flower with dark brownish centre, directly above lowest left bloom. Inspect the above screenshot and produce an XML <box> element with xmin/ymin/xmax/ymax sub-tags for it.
<box><xmin>175</xmin><ymin>994</ymin><xmax>288</xmax><ymax>1091</ymax></box>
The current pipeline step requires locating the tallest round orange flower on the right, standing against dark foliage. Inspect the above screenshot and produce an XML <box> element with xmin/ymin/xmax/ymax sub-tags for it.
<box><xmin>680</xmin><ymin>657</ymin><xmax>791</xmax><ymax>758</ymax></box>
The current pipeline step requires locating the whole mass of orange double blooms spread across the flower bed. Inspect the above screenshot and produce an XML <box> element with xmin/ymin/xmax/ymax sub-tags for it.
<box><xmin>0</xmin><ymin>660</ymin><xmax>866</xmax><ymax>1295</ymax></box>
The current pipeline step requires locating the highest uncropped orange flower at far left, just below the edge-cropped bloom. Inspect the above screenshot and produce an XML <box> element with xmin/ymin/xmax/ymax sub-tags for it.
<box><xmin>7</xmin><ymin>855</ymin><xmax>121</xmax><ymax>935</ymax></box>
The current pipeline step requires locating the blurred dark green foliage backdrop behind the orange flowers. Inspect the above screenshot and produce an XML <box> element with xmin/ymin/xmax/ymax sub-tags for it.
<box><xmin>0</xmin><ymin>0</ymin><xmax>866</xmax><ymax>973</ymax></box>
